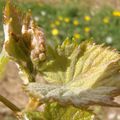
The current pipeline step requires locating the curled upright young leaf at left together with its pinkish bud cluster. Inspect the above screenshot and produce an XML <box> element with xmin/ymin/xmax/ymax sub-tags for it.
<box><xmin>3</xmin><ymin>0</ymin><xmax>46</xmax><ymax>81</ymax></box>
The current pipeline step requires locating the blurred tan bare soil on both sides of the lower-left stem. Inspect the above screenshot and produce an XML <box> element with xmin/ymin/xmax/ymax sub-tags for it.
<box><xmin>0</xmin><ymin>63</ymin><xmax>27</xmax><ymax>120</ymax></box>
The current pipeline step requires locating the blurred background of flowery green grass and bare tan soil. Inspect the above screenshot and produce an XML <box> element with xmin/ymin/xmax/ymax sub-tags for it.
<box><xmin>0</xmin><ymin>0</ymin><xmax>120</xmax><ymax>120</ymax></box>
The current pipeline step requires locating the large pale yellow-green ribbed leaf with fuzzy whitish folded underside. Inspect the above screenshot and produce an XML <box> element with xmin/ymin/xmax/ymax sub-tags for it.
<box><xmin>25</xmin><ymin>41</ymin><xmax>120</xmax><ymax>107</ymax></box>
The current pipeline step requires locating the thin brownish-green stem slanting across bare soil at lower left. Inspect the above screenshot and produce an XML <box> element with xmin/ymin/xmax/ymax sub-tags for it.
<box><xmin>0</xmin><ymin>95</ymin><xmax>21</xmax><ymax>112</ymax></box>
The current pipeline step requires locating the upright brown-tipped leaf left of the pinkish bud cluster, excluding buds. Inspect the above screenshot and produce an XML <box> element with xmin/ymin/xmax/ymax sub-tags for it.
<box><xmin>3</xmin><ymin>0</ymin><xmax>30</xmax><ymax>61</ymax></box>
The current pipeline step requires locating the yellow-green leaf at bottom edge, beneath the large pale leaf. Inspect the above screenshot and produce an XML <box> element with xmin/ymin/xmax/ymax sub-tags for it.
<box><xmin>44</xmin><ymin>103</ymin><xmax>94</xmax><ymax>120</ymax></box>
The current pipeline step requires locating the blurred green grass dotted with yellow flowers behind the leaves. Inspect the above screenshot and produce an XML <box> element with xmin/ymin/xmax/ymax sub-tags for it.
<box><xmin>0</xmin><ymin>1</ymin><xmax>120</xmax><ymax>50</ymax></box>
